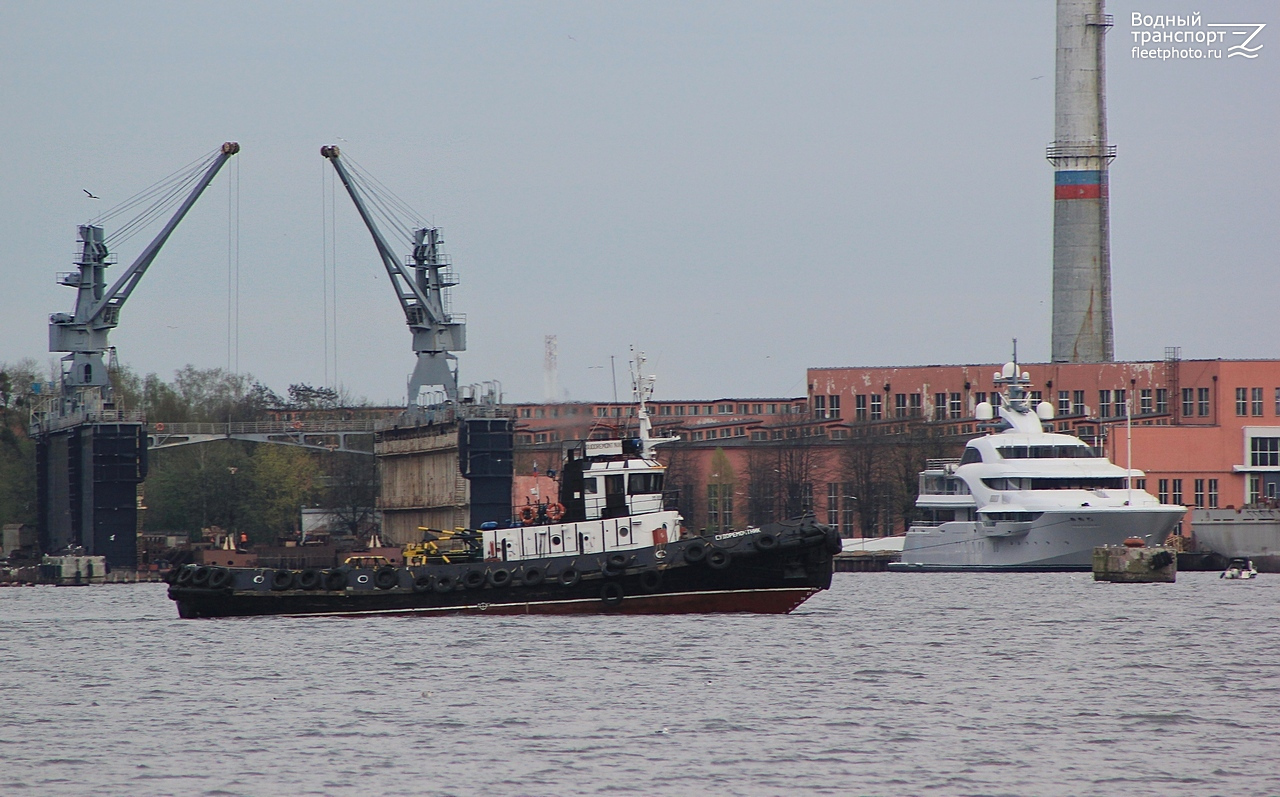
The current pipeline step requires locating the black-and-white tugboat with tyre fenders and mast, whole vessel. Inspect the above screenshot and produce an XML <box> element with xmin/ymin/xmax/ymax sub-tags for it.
<box><xmin>169</xmin><ymin>356</ymin><xmax>841</xmax><ymax>618</ymax></box>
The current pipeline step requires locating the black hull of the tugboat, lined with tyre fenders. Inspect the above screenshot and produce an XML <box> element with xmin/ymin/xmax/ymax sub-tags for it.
<box><xmin>169</xmin><ymin>517</ymin><xmax>840</xmax><ymax>618</ymax></box>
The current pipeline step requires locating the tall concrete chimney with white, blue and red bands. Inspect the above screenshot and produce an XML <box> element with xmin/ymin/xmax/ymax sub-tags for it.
<box><xmin>1047</xmin><ymin>0</ymin><xmax>1116</xmax><ymax>362</ymax></box>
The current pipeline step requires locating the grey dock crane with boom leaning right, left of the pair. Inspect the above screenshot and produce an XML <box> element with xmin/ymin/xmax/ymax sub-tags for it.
<box><xmin>49</xmin><ymin>141</ymin><xmax>239</xmax><ymax>414</ymax></box>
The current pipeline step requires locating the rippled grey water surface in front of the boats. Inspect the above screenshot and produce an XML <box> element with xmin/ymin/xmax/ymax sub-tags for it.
<box><xmin>0</xmin><ymin>573</ymin><xmax>1280</xmax><ymax>797</ymax></box>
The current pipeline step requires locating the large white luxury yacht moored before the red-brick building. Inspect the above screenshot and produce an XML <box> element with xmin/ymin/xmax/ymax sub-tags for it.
<box><xmin>890</xmin><ymin>362</ymin><xmax>1187</xmax><ymax>571</ymax></box>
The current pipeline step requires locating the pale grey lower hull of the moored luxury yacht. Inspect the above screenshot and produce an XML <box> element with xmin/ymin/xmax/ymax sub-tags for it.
<box><xmin>888</xmin><ymin>507</ymin><xmax>1184</xmax><ymax>572</ymax></box>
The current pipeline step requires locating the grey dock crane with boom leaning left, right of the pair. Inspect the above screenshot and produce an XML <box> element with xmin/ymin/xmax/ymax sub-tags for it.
<box><xmin>320</xmin><ymin>146</ymin><xmax>467</xmax><ymax>407</ymax></box>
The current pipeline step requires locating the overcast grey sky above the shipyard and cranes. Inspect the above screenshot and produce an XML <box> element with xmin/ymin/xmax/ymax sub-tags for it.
<box><xmin>0</xmin><ymin>0</ymin><xmax>1280</xmax><ymax>400</ymax></box>
